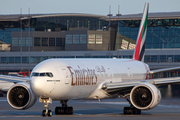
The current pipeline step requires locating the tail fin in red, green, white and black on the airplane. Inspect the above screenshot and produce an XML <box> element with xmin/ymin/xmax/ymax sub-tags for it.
<box><xmin>133</xmin><ymin>3</ymin><xmax>149</xmax><ymax>61</ymax></box>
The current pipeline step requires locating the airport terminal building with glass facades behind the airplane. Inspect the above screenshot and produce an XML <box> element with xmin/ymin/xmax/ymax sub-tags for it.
<box><xmin>0</xmin><ymin>12</ymin><xmax>180</xmax><ymax>76</ymax></box>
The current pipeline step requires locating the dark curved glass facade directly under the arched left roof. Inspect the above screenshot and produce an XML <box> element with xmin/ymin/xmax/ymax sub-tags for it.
<box><xmin>31</xmin><ymin>16</ymin><xmax>108</xmax><ymax>31</ymax></box>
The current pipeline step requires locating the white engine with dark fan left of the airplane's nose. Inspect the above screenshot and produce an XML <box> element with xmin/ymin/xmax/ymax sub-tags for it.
<box><xmin>7</xmin><ymin>82</ymin><xmax>37</xmax><ymax>110</ymax></box>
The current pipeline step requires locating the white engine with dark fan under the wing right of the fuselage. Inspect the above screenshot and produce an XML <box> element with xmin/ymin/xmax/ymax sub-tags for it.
<box><xmin>130</xmin><ymin>82</ymin><xmax>161</xmax><ymax>110</ymax></box>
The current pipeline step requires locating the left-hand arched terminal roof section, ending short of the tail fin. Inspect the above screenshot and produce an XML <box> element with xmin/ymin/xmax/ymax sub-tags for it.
<box><xmin>0</xmin><ymin>13</ymin><xmax>106</xmax><ymax>21</ymax></box>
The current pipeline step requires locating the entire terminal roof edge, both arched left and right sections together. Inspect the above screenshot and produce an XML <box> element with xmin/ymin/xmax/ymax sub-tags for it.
<box><xmin>0</xmin><ymin>12</ymin><xmax>180</xmax><ymax>21</ymax></box>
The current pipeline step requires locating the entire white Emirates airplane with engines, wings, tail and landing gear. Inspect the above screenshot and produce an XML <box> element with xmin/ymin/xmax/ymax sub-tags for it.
<box><xmin>0</xmin><ymin>3</ymin><xmax>180</xmax><ymax>117</ymax></box>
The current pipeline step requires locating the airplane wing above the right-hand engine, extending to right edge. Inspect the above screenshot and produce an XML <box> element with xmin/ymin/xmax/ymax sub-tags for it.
<box><xmin>102</xmin><ymin>77</ymin><xmax>180</xmax><ymax>94</ymax></box>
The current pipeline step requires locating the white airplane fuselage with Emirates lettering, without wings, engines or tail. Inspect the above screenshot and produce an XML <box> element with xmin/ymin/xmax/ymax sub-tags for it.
<box><xmin>30</xmin><ymin>59</ymin><xmax>149</xmax><ymax>100</ymax></box>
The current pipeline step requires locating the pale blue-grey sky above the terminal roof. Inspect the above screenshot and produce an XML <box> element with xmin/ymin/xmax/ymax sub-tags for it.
<box><xmin>0</xmin><ymin>0</ymin><xmax>180</xmax><ymax>16</ymax></box>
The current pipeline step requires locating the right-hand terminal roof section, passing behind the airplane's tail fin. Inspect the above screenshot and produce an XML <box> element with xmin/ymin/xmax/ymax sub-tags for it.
<box><xmin>102</xmin><ymin>12</ymin><xmax>180</xmax><ymax>21</ymax></box>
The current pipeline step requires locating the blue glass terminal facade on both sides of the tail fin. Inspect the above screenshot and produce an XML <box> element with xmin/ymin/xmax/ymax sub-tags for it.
<box><xmin>116</xmin><ymin>19</ymin><xmax>180</xmax><ymax>49</ymax></box>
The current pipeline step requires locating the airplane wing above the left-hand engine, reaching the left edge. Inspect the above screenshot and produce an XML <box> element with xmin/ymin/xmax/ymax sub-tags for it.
<box><xmin>0</xmin><ymin>75</ymin><xmax>30</xmax><ymax>83</ymax></box>
